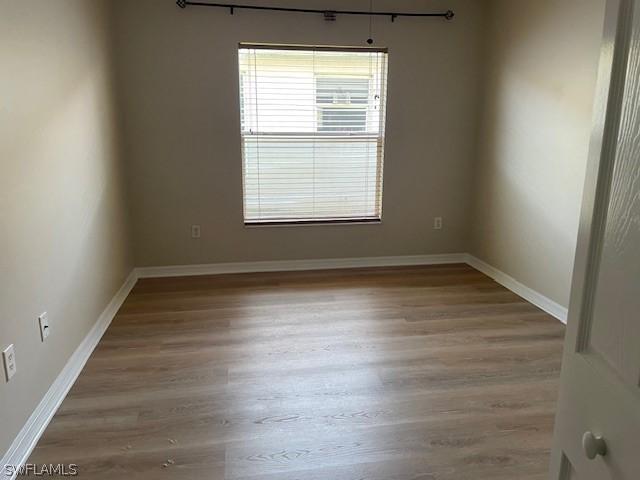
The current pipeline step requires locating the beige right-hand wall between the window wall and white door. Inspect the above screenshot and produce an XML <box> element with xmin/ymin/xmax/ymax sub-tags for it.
<box><xmin>471</xmin><ymin>0</ymin><xmax>605</xmax><ymax>306</ymax></box>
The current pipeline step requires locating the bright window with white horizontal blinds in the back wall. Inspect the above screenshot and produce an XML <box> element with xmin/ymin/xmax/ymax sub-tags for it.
<box><xmin>239</xmin><ymin>44</ymin><xmax>387</xmax><ymax>224</ymax></box>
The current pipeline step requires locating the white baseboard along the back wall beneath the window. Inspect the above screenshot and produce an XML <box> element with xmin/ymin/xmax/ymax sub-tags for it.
<box><xmin>137</xmin><ymin>253</ymin><xmax>467</xmax><ymax>278</ymax></box>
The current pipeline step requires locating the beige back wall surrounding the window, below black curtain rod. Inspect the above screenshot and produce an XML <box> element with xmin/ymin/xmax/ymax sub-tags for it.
<box><xmin>117</xmin><ymin>0</ymin><xmax>482</xmax><ymax>266</ymax></box>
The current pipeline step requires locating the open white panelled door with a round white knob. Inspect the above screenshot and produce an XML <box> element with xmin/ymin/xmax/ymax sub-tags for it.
<box><xmin>551</xmin><ymin>0</ymin><xmax>640</xmax><ymax>480</ymax></box>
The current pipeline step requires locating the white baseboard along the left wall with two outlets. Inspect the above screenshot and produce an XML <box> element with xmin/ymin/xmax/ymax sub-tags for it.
<box><xmin>0</xmin><ymin>269</ymin><xmax>138</xmax><ymax>480</ymax></box>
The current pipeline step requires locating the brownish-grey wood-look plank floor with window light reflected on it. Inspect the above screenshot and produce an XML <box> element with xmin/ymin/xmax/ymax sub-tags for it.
<box><xmin>29</xmin><ymin>265</ymin><xmax>564</xmax><ymax>480</ymax></box>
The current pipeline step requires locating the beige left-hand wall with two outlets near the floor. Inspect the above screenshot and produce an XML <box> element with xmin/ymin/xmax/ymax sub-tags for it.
<box><xmin>0</xmin><ymin>0</ymin><xmax>133</xmax><ymax>456</ymax></box>
